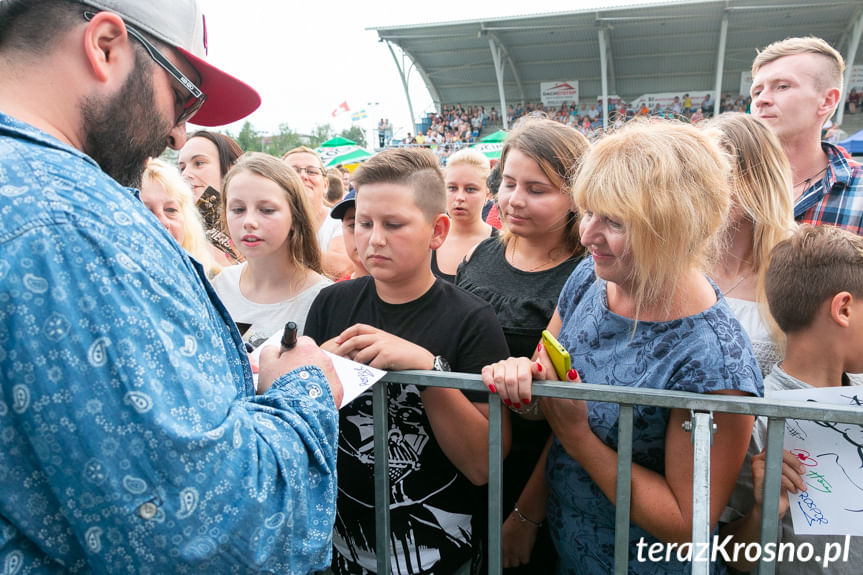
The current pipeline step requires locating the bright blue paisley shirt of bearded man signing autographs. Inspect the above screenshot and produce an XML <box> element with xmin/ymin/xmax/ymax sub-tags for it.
<box><xmin>0</xmin><ymin>114</ymin><xmax>338</xmax><ymax>575</ymax></box>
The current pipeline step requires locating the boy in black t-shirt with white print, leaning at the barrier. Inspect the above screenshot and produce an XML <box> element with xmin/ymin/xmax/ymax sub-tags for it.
<box><xmin>305</xmin><ymin>148</ymin><xmax>509</xmax><ymax>574</ymax></box>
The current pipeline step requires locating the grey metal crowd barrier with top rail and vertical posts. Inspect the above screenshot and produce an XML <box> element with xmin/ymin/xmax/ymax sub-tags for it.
<box><xmin>373</xmin><ymin>371</ymin><xmax>863</xmax><ymax>575</ymax></box>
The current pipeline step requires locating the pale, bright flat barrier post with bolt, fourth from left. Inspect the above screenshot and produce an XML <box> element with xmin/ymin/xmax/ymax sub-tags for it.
<box><xmin>683</xmin><ymin>411</ymin><xmax>715</xmax><ymax>575</ymax></box>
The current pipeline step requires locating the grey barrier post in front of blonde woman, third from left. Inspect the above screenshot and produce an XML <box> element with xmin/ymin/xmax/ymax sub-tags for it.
<box><xmin>614</xmin><ymin>405</ymin><xmax>632</xmax><ymax>575</ymax></box>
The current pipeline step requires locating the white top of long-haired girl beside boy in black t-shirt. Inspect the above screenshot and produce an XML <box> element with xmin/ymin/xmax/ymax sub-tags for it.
<box><xmin>213</xmin><ymin>262</ymin><xmax>330</xmax><ymax>343</ymax></box>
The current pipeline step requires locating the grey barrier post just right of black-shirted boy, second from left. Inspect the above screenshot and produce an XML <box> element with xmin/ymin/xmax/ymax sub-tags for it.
<box><xmin>488</xmin><ymin>394</ymin><xmax>502</xmax><ymax>575</ymax></box>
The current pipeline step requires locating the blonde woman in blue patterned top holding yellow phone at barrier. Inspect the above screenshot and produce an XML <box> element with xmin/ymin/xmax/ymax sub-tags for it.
<box><xmin>483</xmin><ymin>120</ymin><xmax>762</xmax><ymax>575</ymax></box>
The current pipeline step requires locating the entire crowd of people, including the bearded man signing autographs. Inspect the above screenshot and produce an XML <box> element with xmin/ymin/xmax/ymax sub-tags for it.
<box><xmin>0</xmin><ymin>0</ymin><xmax>863</xmax><ymax>575</ymax></box>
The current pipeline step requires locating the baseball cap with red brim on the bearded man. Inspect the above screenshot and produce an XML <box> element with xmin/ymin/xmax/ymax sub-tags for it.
<box><xmin>80</xmin><ymin>0</ymin><xmax>261</xmax><ymax>126</ymax></box>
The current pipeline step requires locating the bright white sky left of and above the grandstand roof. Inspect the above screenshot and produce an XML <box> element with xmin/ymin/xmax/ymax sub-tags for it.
<box><xmin>190</xmin><ymin>0</ymin><xmax>672</xmax><ymax>143</ymax></box>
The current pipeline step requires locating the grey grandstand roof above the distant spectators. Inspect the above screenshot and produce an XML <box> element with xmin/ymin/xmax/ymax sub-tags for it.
<box><xmin>372</xmin><ymin>0</ymin><xmax>863</xmax><ymax>115</ymax></box>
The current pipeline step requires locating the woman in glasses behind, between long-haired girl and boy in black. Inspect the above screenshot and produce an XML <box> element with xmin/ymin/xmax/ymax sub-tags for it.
<box><xmin>282</xmin><ymin>146</ymin><xmax>353</xmax><ymax>279</ymax></box>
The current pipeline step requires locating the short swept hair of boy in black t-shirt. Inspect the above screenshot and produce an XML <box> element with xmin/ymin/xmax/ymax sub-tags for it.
<box><xmin>353</xmin><ymin>148</ymin><xmax>446</xmax><ymax>222</ymax></box>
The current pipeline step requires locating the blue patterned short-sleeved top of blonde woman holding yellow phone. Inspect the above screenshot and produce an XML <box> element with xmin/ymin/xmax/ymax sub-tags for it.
<box><xmin>546</xmin><ymin>257</ymin><xmax>763</xmax><ymax>575</ymax></box>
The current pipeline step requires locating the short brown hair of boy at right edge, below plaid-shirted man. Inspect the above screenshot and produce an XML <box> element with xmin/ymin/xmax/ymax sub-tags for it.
<box><xmin>764</xmin><ymin>224</ymin><xmax>863</xmax><ymax>333</ymax></box>
